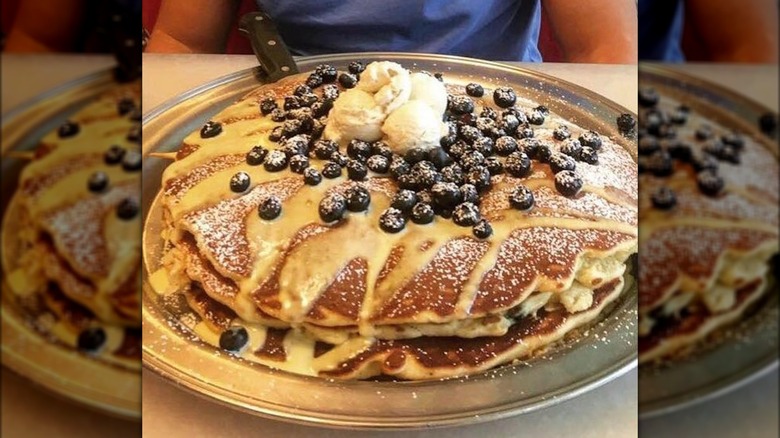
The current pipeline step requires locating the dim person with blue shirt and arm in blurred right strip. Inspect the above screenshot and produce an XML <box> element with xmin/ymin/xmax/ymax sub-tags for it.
<box><xmin>638</xmin><ymin>0</ymin><xmax>778</xmax><ymax>63</ymax></box>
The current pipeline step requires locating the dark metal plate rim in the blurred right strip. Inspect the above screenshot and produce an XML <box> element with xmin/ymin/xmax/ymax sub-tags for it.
<box><xmin>639</xmin><ymin>65</ymin><xmax>778</xmax><ymax>418</ymax></box>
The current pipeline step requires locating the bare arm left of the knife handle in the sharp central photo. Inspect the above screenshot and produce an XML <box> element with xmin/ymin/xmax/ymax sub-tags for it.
<box><xmin>146</xmin><ymin>0</ymin><xmax>239</xmax><ymax>53</ymax></box>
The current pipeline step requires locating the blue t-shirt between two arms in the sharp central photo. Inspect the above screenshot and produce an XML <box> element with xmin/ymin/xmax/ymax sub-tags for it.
<box><xmin>257</xmin><ymin>0</ymin><xmax>542</xmax><ymax>62</ymax></box>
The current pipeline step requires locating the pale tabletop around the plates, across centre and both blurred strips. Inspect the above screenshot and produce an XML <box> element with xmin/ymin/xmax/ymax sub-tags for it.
<box><xmin>0</xmin><ymin>54</ymin><xmax>778</xmax><ymax>438</ymax></box>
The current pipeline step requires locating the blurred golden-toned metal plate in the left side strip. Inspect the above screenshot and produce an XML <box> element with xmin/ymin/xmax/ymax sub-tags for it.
<box><xmin>0</xmin><ymin>71</ymin><xmax>141</xmax><ymax>419</ymax></box>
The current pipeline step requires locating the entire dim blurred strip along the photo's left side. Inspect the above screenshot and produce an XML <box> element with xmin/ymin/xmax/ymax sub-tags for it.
<box><xmin>0</xmin><ymin>0</ymin><xmax>142</xmax><ymax>437</ymax></box>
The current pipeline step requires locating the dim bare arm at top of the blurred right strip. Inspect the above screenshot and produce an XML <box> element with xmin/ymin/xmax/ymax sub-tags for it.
<box><xmin>685</xmin><ymin>0</ymin><xmax>778</xmax><ymax>63</ymax></box>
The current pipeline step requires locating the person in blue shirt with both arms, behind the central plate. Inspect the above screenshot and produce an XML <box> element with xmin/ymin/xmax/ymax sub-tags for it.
<box><xmin>146</xmin><ymin>0</ymin><xmax>637</xmax><ymax>63</ymax></box>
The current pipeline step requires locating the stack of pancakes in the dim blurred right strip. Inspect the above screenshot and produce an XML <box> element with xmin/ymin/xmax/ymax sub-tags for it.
<box><xmin>639</xmin><ymin>89</ymin><xmax>778</xmax><ymax>362</ymax></box>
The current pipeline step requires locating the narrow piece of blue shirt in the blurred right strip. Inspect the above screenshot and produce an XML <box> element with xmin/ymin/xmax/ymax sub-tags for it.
<box><xmin>638</xmin><ymin>0</ymin><xmax>685</xmax><ymax>62</ymax></box>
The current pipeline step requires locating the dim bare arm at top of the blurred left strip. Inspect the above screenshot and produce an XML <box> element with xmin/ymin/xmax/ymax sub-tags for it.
<box><xmin>5</xmin><ymin>0</ymin><xmax>84</xmax><ymax>52</ymax></box>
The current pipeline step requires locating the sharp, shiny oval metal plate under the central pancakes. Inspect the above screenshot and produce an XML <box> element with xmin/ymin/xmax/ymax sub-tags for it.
<box><xmin>143</xmin><ymin>53</ymin><xmax>637</xmax><ymax>429</ymax></box>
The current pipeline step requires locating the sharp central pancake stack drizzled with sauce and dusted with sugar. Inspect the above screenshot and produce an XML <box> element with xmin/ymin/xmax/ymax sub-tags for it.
<box><xmin>151</xmin><ymin>64</ymin><xmax>637</xmax><ymax>379</ymax></box>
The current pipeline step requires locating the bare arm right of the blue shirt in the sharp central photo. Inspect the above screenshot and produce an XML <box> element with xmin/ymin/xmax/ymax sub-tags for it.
<box><xmin>543</xmin><ymin>0</ymin><xmax>638</xmax><ymax>64</ymax></box>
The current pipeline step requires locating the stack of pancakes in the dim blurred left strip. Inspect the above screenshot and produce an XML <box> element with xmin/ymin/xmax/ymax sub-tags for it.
<box><xmin>3</xmin><ymin>82</ymin><xmax>141</xmax><ymax>369</ymax></box>
